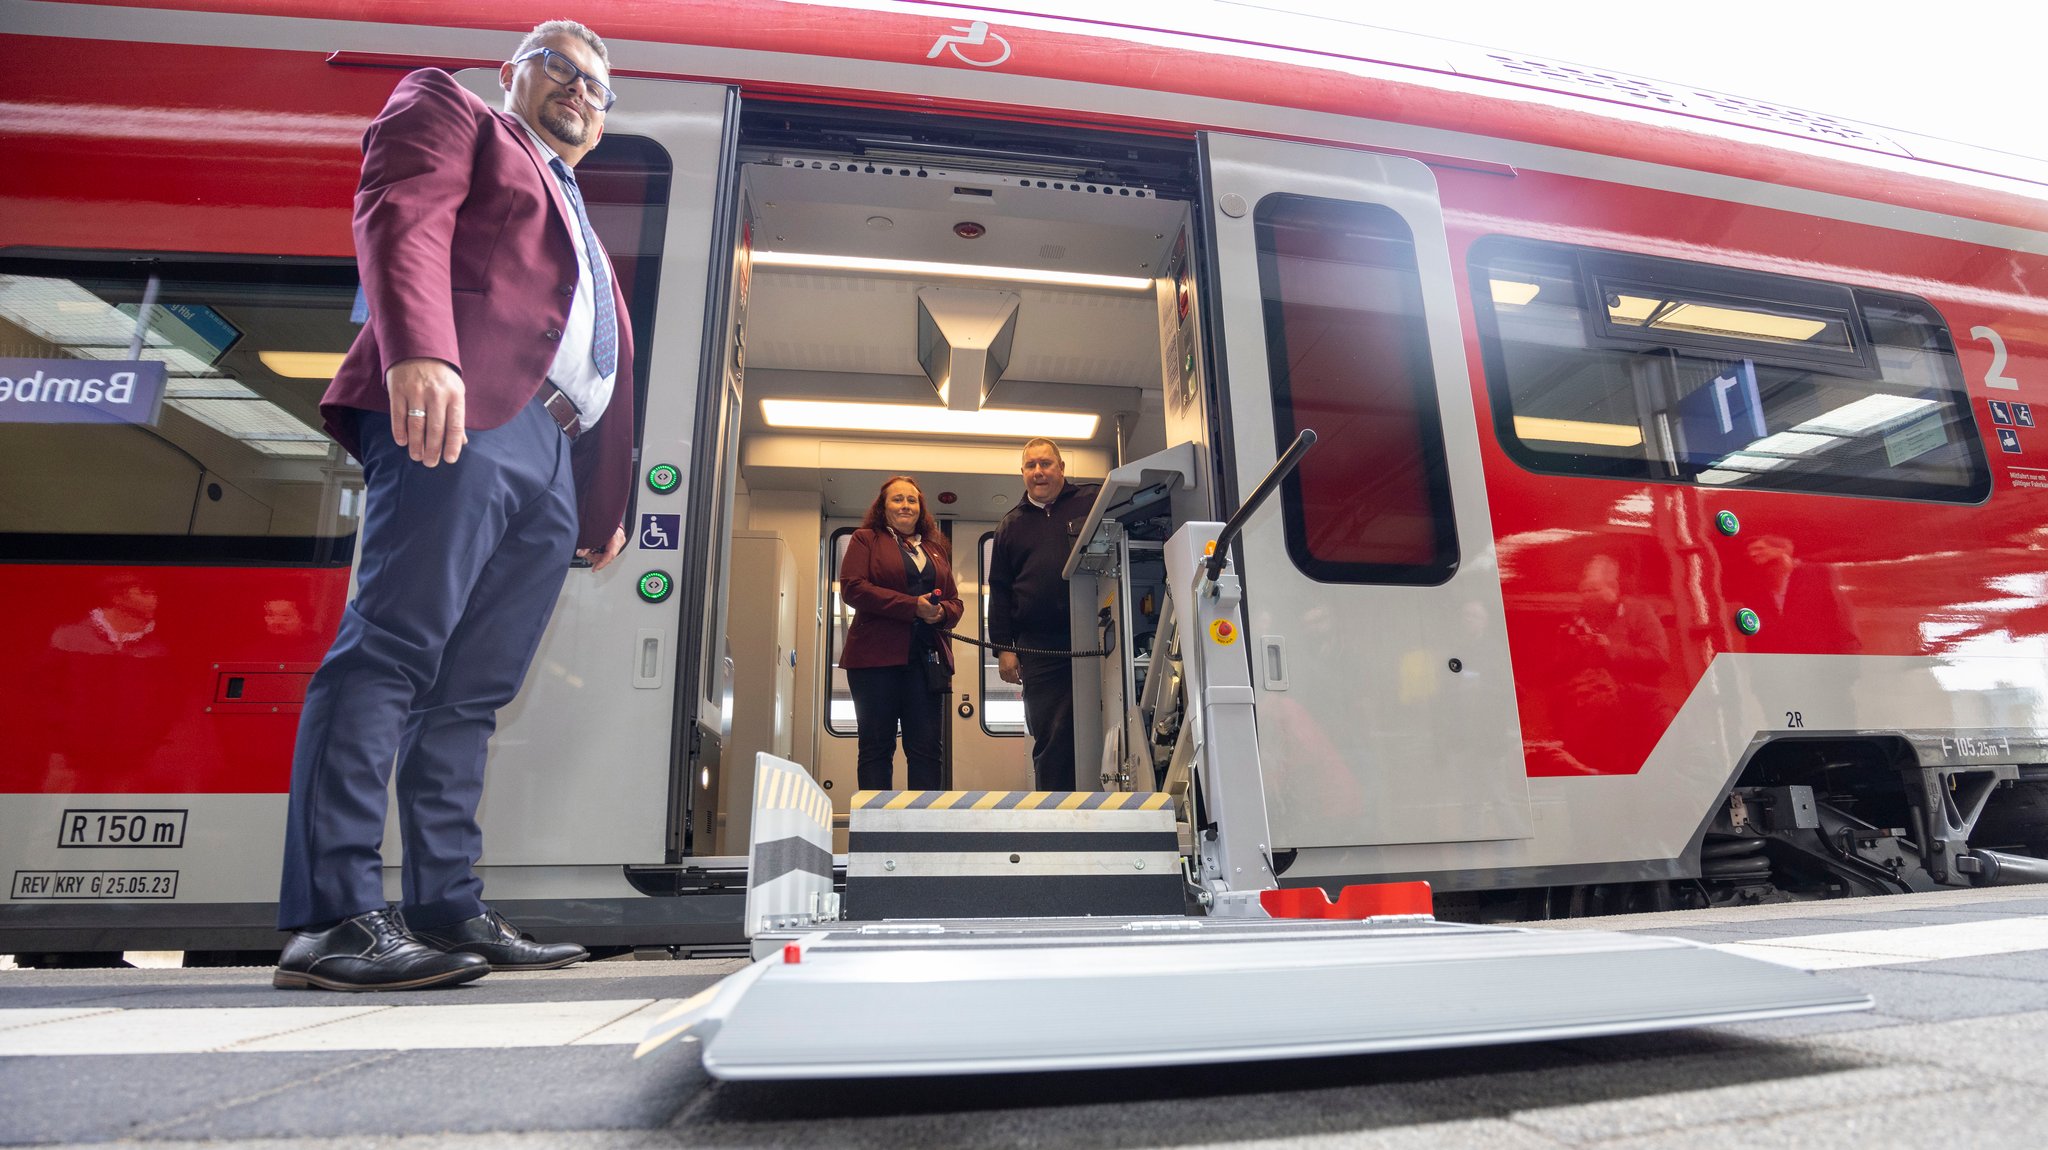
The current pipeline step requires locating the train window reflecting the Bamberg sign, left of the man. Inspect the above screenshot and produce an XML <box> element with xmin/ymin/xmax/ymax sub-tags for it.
<box><xmin>0</xmin><ymin>254</ymin><xmax>362</xmax><ymax>567</ymax></box>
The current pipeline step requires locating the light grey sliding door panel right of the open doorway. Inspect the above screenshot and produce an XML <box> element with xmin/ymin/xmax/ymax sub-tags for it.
<box><xmin>1202</xmin><ymin>135</ymin><xmax>1530</xmax><ymax>859</ymax></box>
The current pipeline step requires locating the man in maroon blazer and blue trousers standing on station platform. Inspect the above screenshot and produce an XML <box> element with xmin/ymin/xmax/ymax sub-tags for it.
<box><xmin>272</xmin><ymin>20</ymin><xmax>633</xmax><ymax>990</ymax></box>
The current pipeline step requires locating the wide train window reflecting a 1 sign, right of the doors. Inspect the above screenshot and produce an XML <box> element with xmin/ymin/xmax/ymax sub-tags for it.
<box><xmin>1473</xmin><ymin>237</ymin><xmax>1991</xmax><ymax>503</ymax></box>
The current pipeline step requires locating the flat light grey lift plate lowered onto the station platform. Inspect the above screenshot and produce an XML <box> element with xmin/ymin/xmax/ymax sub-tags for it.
<box><xmin>641</xmin><ymin>904</ymin><xmax>1872</xmax><ymax>1078</ymax></box>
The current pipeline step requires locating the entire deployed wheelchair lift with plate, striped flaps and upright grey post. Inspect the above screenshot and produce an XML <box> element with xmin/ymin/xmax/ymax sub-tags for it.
<box><xmin>639</xmin><ymin>440</ymin><xmax>1872</xmax><ymax>1078</ymax></box>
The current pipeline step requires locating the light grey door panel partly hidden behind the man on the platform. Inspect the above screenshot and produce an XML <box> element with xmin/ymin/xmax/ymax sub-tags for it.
<box><xmin>436</xmin><ymin>70</ymin><xmax>737</xmax><ymax>904</ymax></box>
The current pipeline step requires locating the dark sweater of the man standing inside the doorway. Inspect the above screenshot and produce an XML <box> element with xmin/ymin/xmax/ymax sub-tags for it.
<box><xmin>985</xmin><ymin>483</ymin><xmax>1096</xmax><ymax>649</ymax></box>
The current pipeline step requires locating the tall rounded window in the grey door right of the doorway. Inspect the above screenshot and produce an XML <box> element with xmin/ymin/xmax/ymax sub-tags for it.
<box><xmin>1253</xmin><ymin>194</ymin><xmax>1458</xmax><ymax>585</ymax></box>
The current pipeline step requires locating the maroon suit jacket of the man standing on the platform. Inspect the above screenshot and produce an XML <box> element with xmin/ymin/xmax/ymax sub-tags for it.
<box><xmin>319</xmin><ymin>68</ymin><xmax>633</xmax><ymax>546</ymax></box>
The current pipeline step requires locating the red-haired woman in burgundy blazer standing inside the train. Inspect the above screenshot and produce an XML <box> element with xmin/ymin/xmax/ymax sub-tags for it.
<box><xmin>840</xmin><ymin>475</ymin><xmax>965</xmax><ymax>790</ymax></box>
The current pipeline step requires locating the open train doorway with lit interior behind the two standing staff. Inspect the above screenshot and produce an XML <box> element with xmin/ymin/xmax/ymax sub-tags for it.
<box><xmin>678</xmin><ymin>106</ymin><xmax>1210</xmax><ymax>859</ymax></box>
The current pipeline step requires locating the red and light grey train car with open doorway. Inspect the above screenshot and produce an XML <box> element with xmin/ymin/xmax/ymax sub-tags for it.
<box><xmin>0</xmin><ymin>0</ymin><xmax>2048</xmax><ymax>956</ymax></box>
